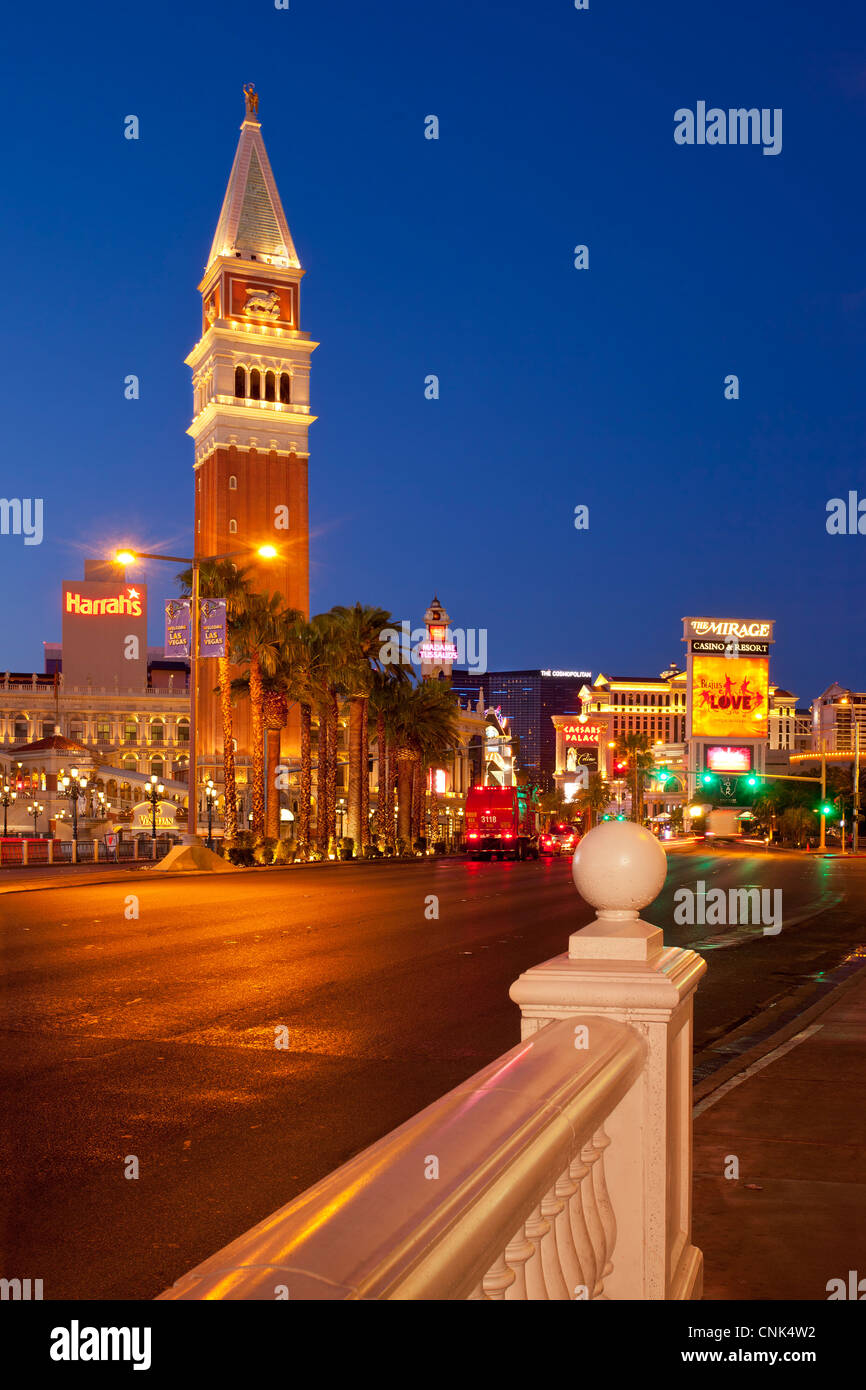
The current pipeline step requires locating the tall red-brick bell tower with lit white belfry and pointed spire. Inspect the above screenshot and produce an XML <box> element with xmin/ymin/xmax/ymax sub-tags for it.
<box><xmin>186</xmin><ymin>88</ymin><xmax>318</xmax><ymax>783</ymax></box>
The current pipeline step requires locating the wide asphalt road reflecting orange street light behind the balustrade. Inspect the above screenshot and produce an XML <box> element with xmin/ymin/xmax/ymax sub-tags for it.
<box><xmin>0</xmin><ymin>847</ymin><xmax>866</xmax><ymax>1298</ymax></box>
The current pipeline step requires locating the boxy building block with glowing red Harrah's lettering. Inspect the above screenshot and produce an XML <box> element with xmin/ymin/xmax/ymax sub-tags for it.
<box><xmin>63</xmin><ymin>580</ymin><xmax>147</xmax><ymax>689</ymax></box>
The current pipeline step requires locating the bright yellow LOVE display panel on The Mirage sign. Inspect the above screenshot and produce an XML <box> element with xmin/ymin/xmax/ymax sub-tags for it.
<box><xmin>689</xmin><ymin>655</ymin><xmax>770</xmax><ymax>739</ymax></box>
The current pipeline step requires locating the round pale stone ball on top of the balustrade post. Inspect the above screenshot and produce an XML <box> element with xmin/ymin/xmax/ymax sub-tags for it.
<box><xmin>571</xmin><ymin>820</ymin><xmax>667</xmax><ymax>919</ymax></box>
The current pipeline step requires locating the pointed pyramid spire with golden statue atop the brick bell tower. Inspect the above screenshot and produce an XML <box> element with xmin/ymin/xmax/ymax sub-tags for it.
<box><xmin>206</xmin><ymin>82</ymin><xmax>300</xmax><ymax>270</ymax></box>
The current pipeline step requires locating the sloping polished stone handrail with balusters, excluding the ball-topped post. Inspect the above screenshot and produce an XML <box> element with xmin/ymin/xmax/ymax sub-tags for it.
<box><xmin>160</xmin><ymin>1017</ymin><xmax>646</xmax><ymax>1300</ymax></box>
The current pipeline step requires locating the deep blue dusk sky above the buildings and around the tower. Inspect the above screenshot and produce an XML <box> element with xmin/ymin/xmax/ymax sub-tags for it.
<box><xmin>0</xmin><ymin>0</ymin><xmax>866</xmax><ymax>702</ymax></box>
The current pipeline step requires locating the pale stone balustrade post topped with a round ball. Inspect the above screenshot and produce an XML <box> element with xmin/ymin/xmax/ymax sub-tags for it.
<box><xmin>510</xmin><ymin>821</ymin><xmax>706</xmax><ymax>1300</ymax></box>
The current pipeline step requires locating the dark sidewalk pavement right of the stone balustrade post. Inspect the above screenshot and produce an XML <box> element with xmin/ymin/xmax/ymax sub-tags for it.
<box><xmin>692</xmin><ymin>970</ymin><xmax>866</xmax><ymax>1301</ymax></box>
